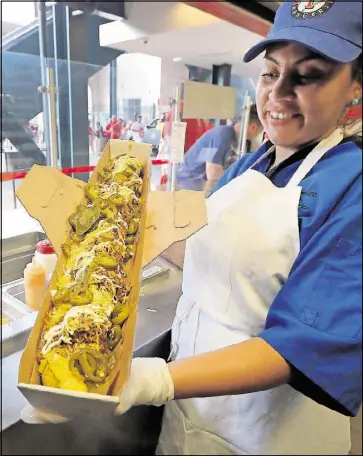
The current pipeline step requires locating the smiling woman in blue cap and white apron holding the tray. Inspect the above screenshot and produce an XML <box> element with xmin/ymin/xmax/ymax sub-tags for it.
<box><xmin>24</xmin><ymin>1</ymin><xmax>362</xmax><ymax>454</ymax></box>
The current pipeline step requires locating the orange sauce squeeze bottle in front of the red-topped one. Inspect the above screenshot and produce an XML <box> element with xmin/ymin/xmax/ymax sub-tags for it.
<box><xmin>24</xmin><ymin>257</ymin><xmax>46</xmax><ymax>310</ymax></box>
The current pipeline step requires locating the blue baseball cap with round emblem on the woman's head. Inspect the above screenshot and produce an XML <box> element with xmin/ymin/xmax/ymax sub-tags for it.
<box><xmin>243</xmin><ymin>0</ymin><xmax>362</xmax><ymax>63</ymax></box>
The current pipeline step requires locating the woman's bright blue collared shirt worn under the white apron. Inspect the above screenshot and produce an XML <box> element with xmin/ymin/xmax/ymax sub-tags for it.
<box><xmin>214</xmin><ymin>140</ymin><xmax>362</xmax><ymax>415</ymax></box>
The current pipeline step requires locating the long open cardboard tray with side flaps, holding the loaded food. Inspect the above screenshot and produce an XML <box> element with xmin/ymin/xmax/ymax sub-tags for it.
<box><xmin>17</xmin><ymin>140</ymin><xmax>207</xmax><ymax>416</ymax></box>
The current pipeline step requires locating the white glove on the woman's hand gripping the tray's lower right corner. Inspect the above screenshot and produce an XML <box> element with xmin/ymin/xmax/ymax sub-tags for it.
<box><xmin>116</xmin><ymin>358</ymin><xmax>174</xmax><ymax>414</ymax></box>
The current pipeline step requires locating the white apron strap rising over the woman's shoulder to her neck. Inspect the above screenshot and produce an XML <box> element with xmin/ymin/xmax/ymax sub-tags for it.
<box><xmin>286</xmin><ymin>128</ymin><xmax>344</xmax><ymax>187</ymax></box>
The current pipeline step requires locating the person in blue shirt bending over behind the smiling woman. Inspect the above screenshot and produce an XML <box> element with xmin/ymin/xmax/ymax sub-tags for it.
<box><xmin>178</xmin><ymin>107</ymin><xmax>262</xmax><ymax>193</ymax></box>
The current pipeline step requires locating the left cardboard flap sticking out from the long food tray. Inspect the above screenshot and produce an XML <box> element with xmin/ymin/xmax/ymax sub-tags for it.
<box><xmin>16</xmin><ymin>165</ymin><xmax>85</xmax><ymax>256</ymax></box>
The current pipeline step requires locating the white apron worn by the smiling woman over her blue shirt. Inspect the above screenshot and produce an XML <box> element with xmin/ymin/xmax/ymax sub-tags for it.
<box><xmin>157</xmin><ymin>130</ymin><xmax>350</xmax><ymax>455</ymax></box>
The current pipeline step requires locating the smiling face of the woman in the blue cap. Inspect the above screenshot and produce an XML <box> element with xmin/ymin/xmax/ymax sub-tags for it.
<box><xmin>256</xmin><ymin>43</ymin><xmax>361</xmax><ymax>149</ymax></box>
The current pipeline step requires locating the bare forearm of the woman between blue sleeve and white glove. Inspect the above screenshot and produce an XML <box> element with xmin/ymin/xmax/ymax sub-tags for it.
<box><xmin>168</xmin><ymin>337</ymin><xmax>291</xmax><ymax>399</ymax></box>
